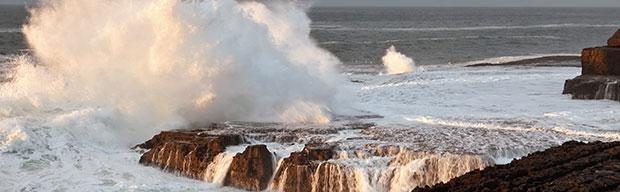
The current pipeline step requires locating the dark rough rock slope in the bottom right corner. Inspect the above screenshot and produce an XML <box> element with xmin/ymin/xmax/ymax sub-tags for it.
<box><xmin>413</xmin><ymin>141</ymin><xmax>620</xmax><ymax>192</ymax></box>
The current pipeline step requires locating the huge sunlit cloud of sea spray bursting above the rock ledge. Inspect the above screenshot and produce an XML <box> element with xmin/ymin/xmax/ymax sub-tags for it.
<box><xmin>0</xmin><ymin>0</ymin><xmax>345</xmax><ymax>142</ymax></box>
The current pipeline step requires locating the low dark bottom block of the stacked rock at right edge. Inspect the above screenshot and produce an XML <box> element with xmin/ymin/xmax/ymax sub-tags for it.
<box><xmin>564</xmin><ymin>75</ymin><xmax>620</xmax><ymax>101</ymax></box>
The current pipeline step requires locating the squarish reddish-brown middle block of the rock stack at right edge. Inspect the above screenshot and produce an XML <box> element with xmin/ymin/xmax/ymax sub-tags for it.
<box><xmin>581</xmin><ymin>47</ymin><xmax>620</xmax><ymax>75</ymax></box>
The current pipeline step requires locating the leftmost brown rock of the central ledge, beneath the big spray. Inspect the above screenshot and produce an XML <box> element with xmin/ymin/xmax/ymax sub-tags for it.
<box><xmin>136</xmin><ymin>130</ymin><xmax>243</xmax><ymax>179</ymax></box>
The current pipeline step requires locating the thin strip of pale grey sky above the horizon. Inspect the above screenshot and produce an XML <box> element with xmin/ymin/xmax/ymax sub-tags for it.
<box><xmin>316</xmin><ymin>0</ymin><xmax>620</xmax><ymax>7</ymax></box>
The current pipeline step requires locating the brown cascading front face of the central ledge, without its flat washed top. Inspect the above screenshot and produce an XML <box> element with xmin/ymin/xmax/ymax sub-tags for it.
<box><xmin>136</xmin><ymin>127</ymin><xmax>492</xmax><ymax>192</ymax></box>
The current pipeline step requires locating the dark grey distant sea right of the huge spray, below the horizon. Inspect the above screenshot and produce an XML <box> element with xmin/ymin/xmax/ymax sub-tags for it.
<box><xmin>309</xmin><ymin>8</ymin><xmax>620</xmax><ymax>65</ymax></box>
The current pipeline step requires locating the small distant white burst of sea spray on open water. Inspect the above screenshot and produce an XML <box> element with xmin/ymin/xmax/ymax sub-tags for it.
<box><xmin>381</xmin><ymin>45</ymin><xmax>415</xmax><ymax>75</ymax></box>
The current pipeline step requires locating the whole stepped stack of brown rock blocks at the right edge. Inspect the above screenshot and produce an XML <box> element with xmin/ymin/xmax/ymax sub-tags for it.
<box><xmin>563</xmin><ymin>30</ymin><xmax>620</xmax><ymax>101</ymax></box>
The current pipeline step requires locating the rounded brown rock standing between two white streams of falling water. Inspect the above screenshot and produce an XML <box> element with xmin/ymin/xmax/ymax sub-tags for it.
<box><xmin>224</xmin><ymin>145</ymin><xmax>275</xmax><ymax>191</ymax></box>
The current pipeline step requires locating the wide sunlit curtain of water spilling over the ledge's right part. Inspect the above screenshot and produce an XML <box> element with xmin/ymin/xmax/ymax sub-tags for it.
<box><xmin>270</xmin><ymin>147</ymin><xmax>492</xmax><ymax>192</ymax></box>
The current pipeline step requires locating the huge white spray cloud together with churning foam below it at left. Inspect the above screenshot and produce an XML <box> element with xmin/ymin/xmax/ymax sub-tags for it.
<box><xmin>0</xmin><ymin>0</ymin><xmax>346</xmax><ymax>191</ymax></box>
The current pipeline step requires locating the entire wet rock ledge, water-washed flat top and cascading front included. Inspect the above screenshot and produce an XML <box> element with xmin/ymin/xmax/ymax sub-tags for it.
<box><xmin>137</xmin><ymin>119</ymin><xmax>616</xmax><ymax>192</ymax></box>
